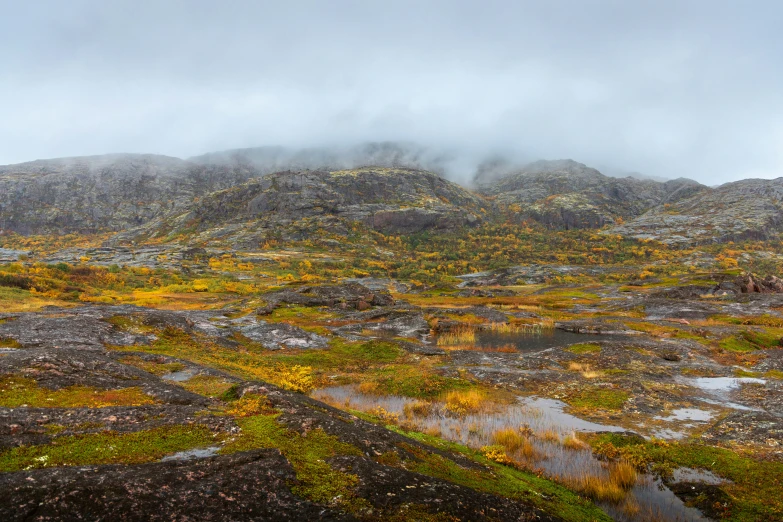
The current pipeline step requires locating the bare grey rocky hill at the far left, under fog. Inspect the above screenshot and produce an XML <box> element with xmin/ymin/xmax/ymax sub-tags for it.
<box><xmin>0</xmin><ymin>154</ymin><xmax>256</xmax><ymax>234</ymax></box>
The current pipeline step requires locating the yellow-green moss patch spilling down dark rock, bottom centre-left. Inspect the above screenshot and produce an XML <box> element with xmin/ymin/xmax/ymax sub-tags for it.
<box><xmin>222</xmin><ymin>414</ymin><xmax>362</xmax><ymax>507</ymax></box>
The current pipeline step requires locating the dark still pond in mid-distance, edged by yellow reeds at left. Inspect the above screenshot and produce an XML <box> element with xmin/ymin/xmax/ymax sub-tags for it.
<box><xmin>440</xmin><ymin>329</ymin><xmax>622</xmax><ymax>352</ymax></box>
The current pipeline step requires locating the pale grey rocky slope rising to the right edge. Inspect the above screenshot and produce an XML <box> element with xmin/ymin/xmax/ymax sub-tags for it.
<box><xmin>611</xmin><ymin>178</ymin><xmax>783</xmax><ymax>244</ymax></box>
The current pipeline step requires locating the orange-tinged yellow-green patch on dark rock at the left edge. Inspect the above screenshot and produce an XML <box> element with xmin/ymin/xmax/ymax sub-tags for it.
<box><xmin>0</xmin><ymin>376</ymin><xmax>155</xmax><ymax>408</ymax></box>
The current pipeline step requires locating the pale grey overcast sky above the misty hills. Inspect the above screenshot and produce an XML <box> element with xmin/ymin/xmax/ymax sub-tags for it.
<box><xmin>0</xmin><ymin>0</ymin><xmax>783</xmax><ymax>185</ymax></box>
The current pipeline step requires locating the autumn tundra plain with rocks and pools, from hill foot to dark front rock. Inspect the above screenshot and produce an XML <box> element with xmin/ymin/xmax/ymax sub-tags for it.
<box><xmin>0</xmin><ymin>210</ymin><xmax>783</xmax><ymax>521</ymax></box>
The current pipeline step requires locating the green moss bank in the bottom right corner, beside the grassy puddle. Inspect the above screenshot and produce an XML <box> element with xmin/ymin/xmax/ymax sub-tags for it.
<box><xmin>590</xmin><ymin>434</ymin><xmax>783</xmax><ymax>522</ymax></box>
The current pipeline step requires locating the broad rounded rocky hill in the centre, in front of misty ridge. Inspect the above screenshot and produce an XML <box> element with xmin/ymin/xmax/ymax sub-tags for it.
<box><xmin>112</xmin><ymin>167</ymin><xmax>492</xmax><ymax>244</ymax></box>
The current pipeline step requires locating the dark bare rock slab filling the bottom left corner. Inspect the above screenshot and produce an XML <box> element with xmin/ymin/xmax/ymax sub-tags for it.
<box><xmin>0</xmin><ymin>449</ymin><xmax>354</xmax><ymax>522</ymax></box>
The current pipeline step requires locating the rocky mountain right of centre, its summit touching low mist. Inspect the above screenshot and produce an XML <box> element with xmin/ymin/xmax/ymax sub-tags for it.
<box><xmin>477</xmin><ymin>160</ymin><xmax>706</xmax><ymax>228</ymax></box>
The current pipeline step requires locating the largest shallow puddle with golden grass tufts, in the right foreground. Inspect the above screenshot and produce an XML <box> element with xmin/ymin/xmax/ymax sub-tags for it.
<box><xmin>312</xmin><ymin>386</ymin><xmax>709</xmax><ymax>522</ymax></box>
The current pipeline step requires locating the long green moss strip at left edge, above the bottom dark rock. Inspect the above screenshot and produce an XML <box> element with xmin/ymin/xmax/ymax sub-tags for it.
<box><xmin>0</xmin><ymin>426</ymin><xmax>220</xmax><ymax>472</ymax></box>
